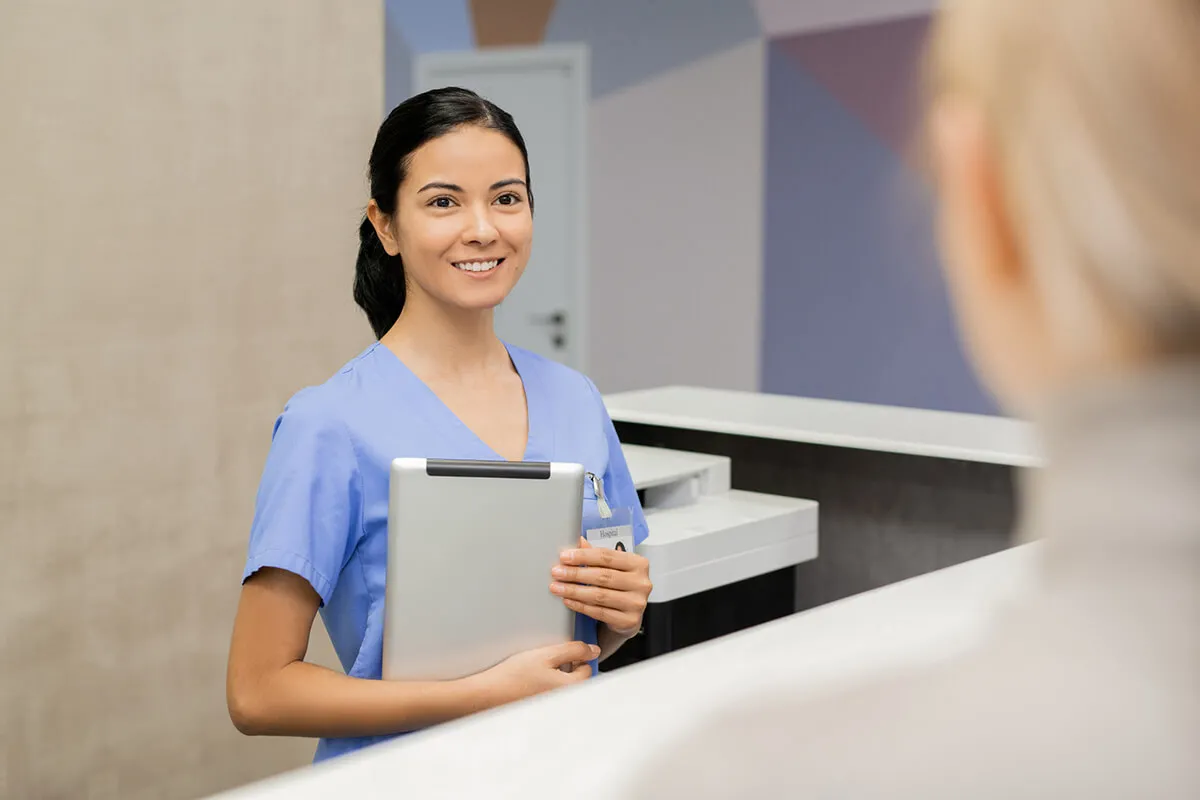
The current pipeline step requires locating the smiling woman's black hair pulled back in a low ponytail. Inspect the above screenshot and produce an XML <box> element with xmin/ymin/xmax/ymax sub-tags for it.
<box><xmin>354</xmin><ymin>86</ymin><xmax>533</xmax><ymax>338</ymax></box>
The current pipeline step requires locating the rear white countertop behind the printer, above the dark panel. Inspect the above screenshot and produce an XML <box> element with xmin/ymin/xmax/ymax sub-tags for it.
<box><xmin>605</xmin><ymin>386</ymin><xmax>1042</xmax><ymax>467</ymax></box>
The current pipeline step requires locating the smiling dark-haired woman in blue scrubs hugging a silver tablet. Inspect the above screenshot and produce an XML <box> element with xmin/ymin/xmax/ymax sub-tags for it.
<box><xmin>227</xmin><ymin>89</ymin><xmax>650</xmax><ymax>760</ymax></box>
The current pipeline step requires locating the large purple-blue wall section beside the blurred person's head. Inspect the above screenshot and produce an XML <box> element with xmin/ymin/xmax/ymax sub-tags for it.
<box><xmin>762</xmin><ymin>42</ymin><xmax>996</xmax><ymax>414</ymax></box>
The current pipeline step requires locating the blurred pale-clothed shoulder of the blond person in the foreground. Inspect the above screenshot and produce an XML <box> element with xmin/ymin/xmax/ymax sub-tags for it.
<box><xmin>619</xmin><ymin>594</ymin><xmax>1200</xmax><ymax>800</ymax></box>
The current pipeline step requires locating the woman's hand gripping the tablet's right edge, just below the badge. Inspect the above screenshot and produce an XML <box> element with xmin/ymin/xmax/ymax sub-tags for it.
<box><xmin>550</xmin><ymin>539</ymin><xmax>653</xmax><ymax>637</ymax></box>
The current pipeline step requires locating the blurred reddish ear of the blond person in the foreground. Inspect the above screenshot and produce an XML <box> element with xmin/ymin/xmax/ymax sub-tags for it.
<box><xmin>930</xmin><ymin>97</ymin><xmax>1026</xmax><ymax>285</ymax></box>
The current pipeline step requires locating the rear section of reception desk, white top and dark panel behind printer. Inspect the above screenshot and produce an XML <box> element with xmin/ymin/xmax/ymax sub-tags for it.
<box><xmin>605</xmin><ymin>386</ymin><xmax>1042</xmax><ymax>618</ymax></box>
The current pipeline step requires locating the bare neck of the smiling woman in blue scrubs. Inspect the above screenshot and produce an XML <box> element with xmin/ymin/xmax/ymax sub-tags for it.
<box><xmin>379</xmin><ymin>295</ymin><xmax>509</xmax><ymax>377</ymax></box>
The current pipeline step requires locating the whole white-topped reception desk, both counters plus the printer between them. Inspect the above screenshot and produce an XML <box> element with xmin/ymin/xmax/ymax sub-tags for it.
<box><xmin>213</xmin><ymin>387</ymin><xmax>1042</xmax><ymax>800</ymax></box>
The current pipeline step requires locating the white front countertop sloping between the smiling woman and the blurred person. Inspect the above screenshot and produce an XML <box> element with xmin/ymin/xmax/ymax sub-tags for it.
<box><xmin>218</xmin><ymin>545</ymin><xmax>1038</xmax><ymax>800</ymax></box>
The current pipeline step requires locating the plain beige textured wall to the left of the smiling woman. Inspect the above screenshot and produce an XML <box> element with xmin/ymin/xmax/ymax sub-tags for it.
<box><xmin>0</xmin><ymin>0</ymin><xmax>383</xmax><ymax>798</ymax></box>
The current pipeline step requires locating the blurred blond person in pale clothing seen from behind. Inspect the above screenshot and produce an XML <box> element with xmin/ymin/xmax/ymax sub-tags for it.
<box><xmin>630</xmin><ymin>0</ymin><xmax>1200</xmax><ymax>799</ymax></box>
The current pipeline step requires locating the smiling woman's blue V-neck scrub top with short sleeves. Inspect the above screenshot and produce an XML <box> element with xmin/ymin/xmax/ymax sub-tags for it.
<box><xmin>242</xmin><ymin>342</ymin><xmax>647</xmax><ymax>762</ymax></box>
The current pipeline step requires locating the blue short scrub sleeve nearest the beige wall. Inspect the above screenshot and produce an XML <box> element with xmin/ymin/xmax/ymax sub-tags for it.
<box><xmin>242</xmin><ymin>393</ymin><xmax>362</xmax><ymax>604</ymax></box>
